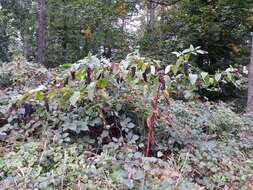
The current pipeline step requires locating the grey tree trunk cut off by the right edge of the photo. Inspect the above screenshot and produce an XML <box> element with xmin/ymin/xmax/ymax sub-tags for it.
<box><xmin>247</xmin><ymin>32</ymin><xmax>253</xmax><ymax>116</ymax></box>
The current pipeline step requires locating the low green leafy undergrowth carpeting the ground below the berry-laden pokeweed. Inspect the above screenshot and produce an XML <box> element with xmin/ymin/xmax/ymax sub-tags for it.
<box><xmin>0</xmin><ymin>101</ymin><xmax>253</xmax><ymax>190</ymax></box>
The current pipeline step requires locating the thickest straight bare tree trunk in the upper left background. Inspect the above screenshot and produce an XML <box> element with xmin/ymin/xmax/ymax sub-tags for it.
<box><xmin>37</xmin><ymin>0</ymin><xmax>45</xmax><ymax>64</ymax></box>
